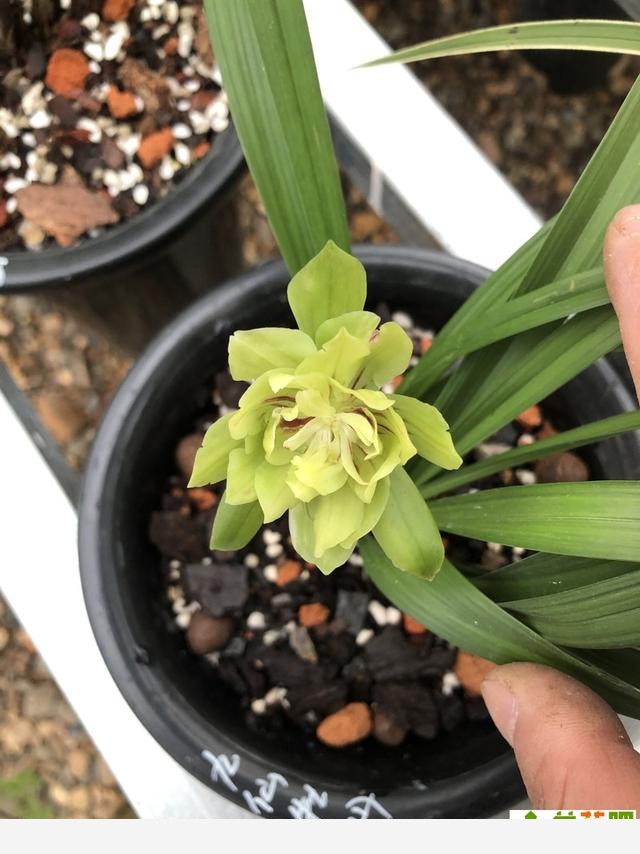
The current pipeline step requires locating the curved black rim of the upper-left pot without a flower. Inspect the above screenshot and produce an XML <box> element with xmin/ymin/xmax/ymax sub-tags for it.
<box><xmin>0</xmin><ymin>123</ymin><xmax>244</xmax><ymax>293</ymax></box>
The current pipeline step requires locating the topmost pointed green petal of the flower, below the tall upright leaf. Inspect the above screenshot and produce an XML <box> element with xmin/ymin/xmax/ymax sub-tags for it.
<box><xmin>287</xmin><ymin>240</ymin><xmax>367</xmax><ymax>338</ymax></box>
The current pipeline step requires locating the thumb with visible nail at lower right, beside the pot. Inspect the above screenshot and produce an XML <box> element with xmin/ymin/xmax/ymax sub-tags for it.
<box><xmin>482</xmin><ymin>664</ymin><xmax>640</xmax><ymax>811</ymax></box>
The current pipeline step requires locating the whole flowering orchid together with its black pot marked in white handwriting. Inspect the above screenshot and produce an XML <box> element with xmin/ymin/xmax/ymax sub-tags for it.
<box><xmin>80</xmin><ymin>0</ymin><xmax>640</xmax><ymax>817</ymax></box>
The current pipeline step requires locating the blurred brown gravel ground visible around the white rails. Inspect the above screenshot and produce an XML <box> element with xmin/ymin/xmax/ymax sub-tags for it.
<box><xmin>0</xmin><ymin>0</ymin><xmax>638</xmax><ymax>818</ymax></box>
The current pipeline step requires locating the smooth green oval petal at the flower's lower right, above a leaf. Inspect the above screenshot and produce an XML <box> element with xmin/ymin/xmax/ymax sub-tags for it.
<box><xmin>373</xmin><ymin>466</ymin><xmax>444</xmax><ymax>579</ymax></box>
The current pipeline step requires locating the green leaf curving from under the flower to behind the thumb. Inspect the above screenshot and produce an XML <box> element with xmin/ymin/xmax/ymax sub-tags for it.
<box><xmin>360</xmin><ymin>537</ymin><xmax>640</xmax><ymax>717</ymax></box>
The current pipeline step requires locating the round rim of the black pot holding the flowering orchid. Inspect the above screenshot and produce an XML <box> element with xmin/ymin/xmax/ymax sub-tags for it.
<box><xmin>84</xmin><ymin>247</ymin><xmax>631</xmax><ymax>817</ymax></box>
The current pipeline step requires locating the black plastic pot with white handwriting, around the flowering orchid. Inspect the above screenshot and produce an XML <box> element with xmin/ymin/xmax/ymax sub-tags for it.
<box><xmin>79</xmin><ymin>247</ymin><xmax>640</xmax><ymax>818</ymax></box>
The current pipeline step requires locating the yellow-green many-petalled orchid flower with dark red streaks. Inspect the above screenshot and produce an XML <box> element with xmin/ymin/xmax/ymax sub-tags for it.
<box><xmin>189</xmin><ymin>237</ymin><xmax>462</xmax><ymax>578</ymax></box>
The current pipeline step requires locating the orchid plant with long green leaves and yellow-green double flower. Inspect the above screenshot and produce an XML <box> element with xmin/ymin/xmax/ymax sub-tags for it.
<box><xmin>199</xmin><ymin>5</ymin><xmax>640</xmax><ymax>714</ymax></box>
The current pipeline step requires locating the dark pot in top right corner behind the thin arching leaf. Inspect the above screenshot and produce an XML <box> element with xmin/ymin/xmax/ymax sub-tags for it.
<box><xmin>516</xmin><ymin>0</ymin><xmax>640</xmax><ymax>95</ymax></box>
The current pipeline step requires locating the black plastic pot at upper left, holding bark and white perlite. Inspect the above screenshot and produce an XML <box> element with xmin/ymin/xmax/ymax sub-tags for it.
<box><xmin>0</xmin><ymin>125</ymin><xmax>244</xmax><ymax>353</ymax></box>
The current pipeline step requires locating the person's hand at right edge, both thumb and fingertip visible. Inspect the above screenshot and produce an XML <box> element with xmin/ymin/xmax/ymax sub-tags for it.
<box><xmin>482</xmin><ymin>205</ymin><xmax>640</xmax><ymax>813</ymax></box>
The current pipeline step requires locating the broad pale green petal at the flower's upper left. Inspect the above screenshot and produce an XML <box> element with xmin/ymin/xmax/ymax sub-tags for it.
<box><xmin>229</xmin><ymin>328</ymin><xmax>316</xmax><ymax>382</ymax></box>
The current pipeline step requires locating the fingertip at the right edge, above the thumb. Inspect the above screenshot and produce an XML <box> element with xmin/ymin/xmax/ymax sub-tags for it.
<box><xmin>604</xmin><ymin>205</ymin><xmax>640</xmax><ymax>397</ymax></box>
